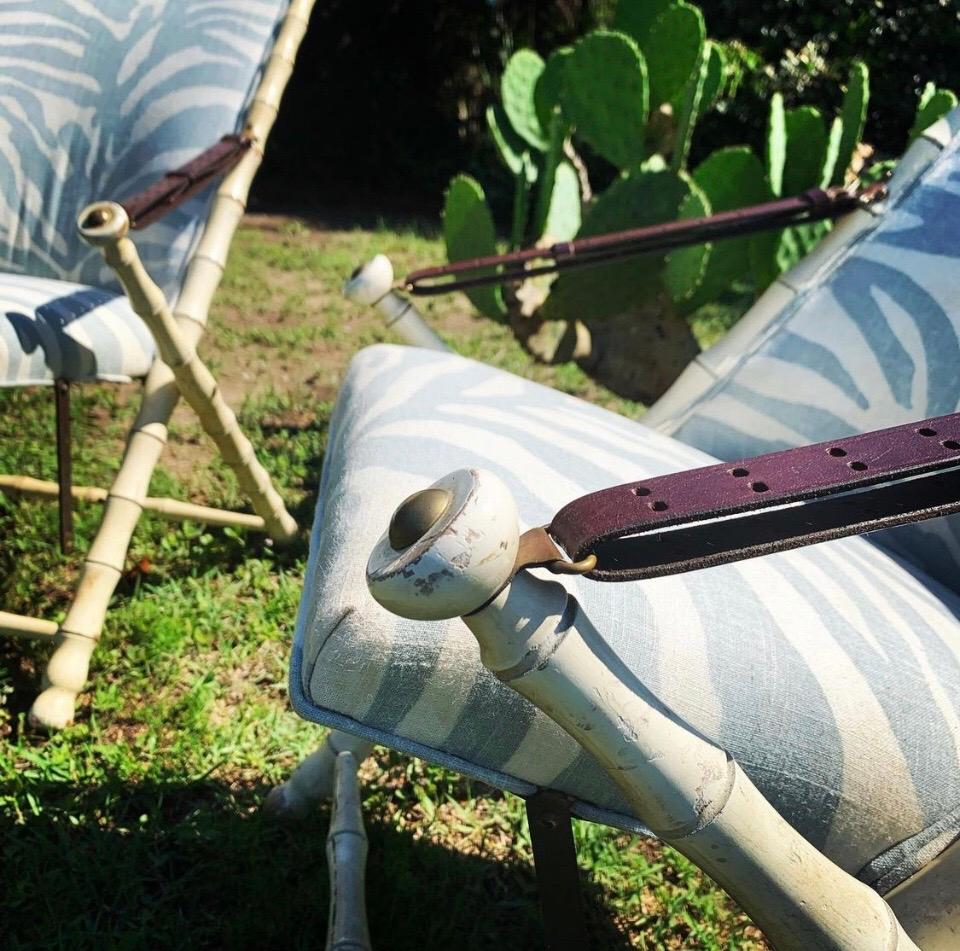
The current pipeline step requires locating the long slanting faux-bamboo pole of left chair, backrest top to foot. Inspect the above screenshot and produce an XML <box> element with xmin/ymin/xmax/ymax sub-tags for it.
<box><xmin>30</xmin><ymin>0</ymin><xmax>315</xmax><ymax>727</ymax></box>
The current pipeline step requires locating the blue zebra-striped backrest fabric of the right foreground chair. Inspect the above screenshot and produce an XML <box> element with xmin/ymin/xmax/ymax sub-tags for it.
<box><xmin>645</xmin><ymin>110</ymin><xmax>960</xmax><ymax>591</ymax></box>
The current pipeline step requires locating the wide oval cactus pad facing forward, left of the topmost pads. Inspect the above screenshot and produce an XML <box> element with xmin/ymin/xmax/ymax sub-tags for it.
<box><xmin>562</xmin><ymin>30</ymin><xmax>648</xmax><ymax>169</ymax></box>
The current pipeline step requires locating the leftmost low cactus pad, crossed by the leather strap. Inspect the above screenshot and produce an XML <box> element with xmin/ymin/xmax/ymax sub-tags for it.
<box><xmin>443</xmin><ymin>175</ymin><xmax>507</xmax><ymax>320</ymax></box>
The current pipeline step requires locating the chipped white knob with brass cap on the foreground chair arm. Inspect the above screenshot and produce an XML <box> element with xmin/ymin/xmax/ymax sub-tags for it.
<box><xmin>367</xmin><ymin>469</ymin><xmax>520</xmax><ymax>621</ymax></box>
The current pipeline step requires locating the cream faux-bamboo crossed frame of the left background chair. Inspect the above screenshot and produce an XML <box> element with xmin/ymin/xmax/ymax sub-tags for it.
<box><xmin>0</xmin><ymin>0</ymin><xmax>315</xmax><ymax>728</ymax></box>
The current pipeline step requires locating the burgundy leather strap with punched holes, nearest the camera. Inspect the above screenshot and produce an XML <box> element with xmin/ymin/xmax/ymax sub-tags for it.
<box><xmin>547</xmin><ymin>413</ymin><xmax>960</xmax><ymax>581</ymax></box>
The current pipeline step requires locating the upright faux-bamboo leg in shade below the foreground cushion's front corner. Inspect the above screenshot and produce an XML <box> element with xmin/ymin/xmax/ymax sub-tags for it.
<box><xmin>327</xmin><ymin>752</ymin><xmax>370</xmax><ymax>951</ymax></box>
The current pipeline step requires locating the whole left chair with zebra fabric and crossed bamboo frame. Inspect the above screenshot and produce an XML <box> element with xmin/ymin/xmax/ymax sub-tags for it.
<box><xmin>0</xmin><ymin>0</ymin><xmax>313</xmax><ymax>727</ymax></box>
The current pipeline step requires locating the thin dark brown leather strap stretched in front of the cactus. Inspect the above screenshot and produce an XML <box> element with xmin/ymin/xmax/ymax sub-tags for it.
<box><xmin>403</xmin><ymin>182</ymin><xmax>886</xmax><ymax>296</ymax></box>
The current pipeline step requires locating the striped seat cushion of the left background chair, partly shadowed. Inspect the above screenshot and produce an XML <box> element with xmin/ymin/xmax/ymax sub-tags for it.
<box><xmin>0</xmin><ymin>274</ymin><xmax>156</xmax><ymax>387</ymax></box>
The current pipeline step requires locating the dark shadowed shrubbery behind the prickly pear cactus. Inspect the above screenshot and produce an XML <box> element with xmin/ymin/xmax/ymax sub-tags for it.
<box><xmin>258</xmin><ymin>0</ymin><xmax>960</xmax><ymax>217</ymax></box>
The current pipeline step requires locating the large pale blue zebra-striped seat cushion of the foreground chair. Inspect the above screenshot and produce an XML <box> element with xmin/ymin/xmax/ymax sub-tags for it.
<box><xmin>291</xmin><ymin>346</ymin><xmax>960</xmax><ymax>890</ymax></box>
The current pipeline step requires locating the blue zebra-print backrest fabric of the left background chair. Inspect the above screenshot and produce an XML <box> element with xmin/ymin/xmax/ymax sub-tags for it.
<box><xmin>0</xmin><ymin>0</ymin><xmax>288</xmax><ymax>304</ymax></box>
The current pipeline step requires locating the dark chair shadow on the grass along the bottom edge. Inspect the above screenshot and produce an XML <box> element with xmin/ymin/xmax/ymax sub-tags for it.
<box><xmin>0</xmin><ymin>777</ymin><xmax>627</xmax><ymax>951</ymax></box>
